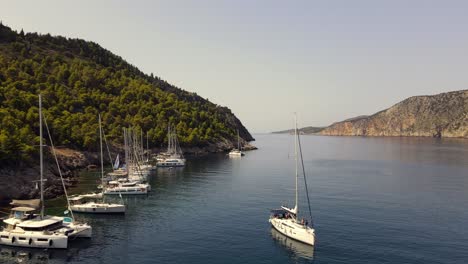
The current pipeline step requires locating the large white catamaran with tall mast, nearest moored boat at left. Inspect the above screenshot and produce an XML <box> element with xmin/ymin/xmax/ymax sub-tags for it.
<box><xmin>0</xmin><ymin>95</ymin><xmax>92</xmax><ymax>248</ymax></box>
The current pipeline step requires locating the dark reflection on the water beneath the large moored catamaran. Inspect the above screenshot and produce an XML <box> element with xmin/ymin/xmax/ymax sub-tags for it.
<box><xmin>0</xmin><ymin>239</ymin><xmax>91</xmax><ymax>264</ymax></box>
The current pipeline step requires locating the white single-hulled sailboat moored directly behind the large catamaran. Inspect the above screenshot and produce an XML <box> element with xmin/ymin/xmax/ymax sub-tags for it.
<box><xmin>70</xmin><ymin>115</ymin><xmax>125</xmax><ymax>214</ymax></box>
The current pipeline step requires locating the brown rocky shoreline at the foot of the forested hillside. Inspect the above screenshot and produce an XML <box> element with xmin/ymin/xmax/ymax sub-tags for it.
<box><xmin>0</xmin><ymin>140</ymin><xmax>257</xmax><ymax>204</ymax></box>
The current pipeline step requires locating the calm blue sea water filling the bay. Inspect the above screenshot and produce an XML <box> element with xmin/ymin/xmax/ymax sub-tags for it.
<box><xmin>0</xmin><ymin>135</ymin><xmax>468</xmax><ymax>264</ymax></box>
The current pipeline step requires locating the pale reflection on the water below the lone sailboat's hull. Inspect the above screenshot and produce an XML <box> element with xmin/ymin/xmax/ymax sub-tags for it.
<box><xmin>271</xmin><ymin>228</ymin><xmax>314</xmax><ymax>262</ymax></box>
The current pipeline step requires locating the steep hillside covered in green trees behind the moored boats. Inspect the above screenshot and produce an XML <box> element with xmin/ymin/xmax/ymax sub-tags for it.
<box><xmin>0</xmin><ymin>25</ymin><xmax>253</xmax><ymax>165</ymax></box>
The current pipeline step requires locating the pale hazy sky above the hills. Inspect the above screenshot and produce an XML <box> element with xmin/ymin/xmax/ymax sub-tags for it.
<box><xmin>0</xmin><ymin>0</ymin><xmax>468</xmax><ymax>132</ymax></box>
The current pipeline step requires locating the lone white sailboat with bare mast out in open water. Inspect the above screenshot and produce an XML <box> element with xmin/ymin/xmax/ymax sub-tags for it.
<box><xmin>269</xmin><ymin>115</ymin><xmax>315</xmax><ymax>246</ymax></box>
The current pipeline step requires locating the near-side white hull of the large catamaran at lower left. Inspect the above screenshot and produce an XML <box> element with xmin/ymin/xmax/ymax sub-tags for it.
<box><xmin>0</xmin><ymin>231</ymin><xmax>68</xmax><ymax>248</ymax></box>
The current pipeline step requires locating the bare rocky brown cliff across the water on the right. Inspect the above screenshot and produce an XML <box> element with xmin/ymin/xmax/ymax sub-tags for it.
<box><xmin>319</xmin><ymin>90</ymin><xmax>468</xmax><ymax>138</ymax></box>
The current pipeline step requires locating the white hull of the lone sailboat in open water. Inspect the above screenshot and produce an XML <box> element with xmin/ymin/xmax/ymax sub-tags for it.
<box><xmin>269</xmin><ymin>217</ymin><xmax>315</xmax><ymax>246</ymax></box>
